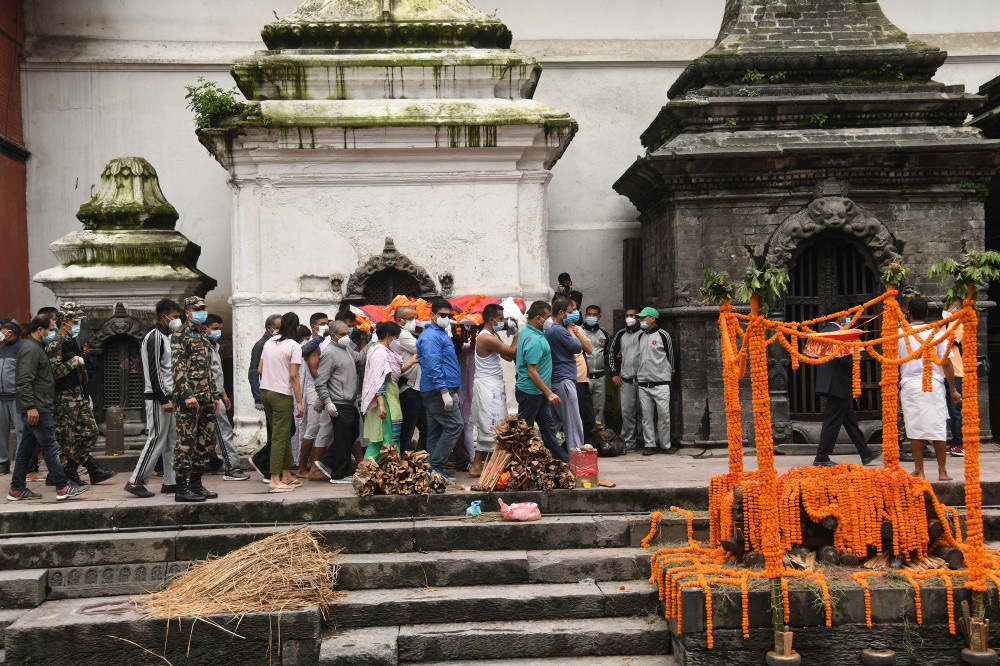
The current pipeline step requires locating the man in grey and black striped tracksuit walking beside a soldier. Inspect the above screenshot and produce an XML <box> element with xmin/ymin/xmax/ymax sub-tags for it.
<box><xmin>125</xmin><ymin>298</ymin><xmax>183</xmax><ymax>497</ymax></box>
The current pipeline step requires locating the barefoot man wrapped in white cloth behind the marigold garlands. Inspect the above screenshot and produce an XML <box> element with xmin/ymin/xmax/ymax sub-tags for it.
<box><xmin>899</xmin><ymin>296</ymin><xmax>962</xmax><ymax>481</ymax></box>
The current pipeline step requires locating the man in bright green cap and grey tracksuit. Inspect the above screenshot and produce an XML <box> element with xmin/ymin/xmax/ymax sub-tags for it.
<box><xmin>635</xmin><ymin>308</ymin><xmax>676</xmax><ymax>456</ymax></box>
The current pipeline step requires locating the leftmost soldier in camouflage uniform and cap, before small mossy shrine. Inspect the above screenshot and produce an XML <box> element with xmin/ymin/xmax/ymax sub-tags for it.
<box><xmin>45</xmin><ymin>301</ymin><xmax>117</xmax><ymax>485</ymax></box>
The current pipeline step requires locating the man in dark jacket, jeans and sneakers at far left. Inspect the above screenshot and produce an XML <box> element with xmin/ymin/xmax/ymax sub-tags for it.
<box><xmin>7</xmin><ymin>315</ymin><xmax>90</xmax><ymax>501</ymax></box>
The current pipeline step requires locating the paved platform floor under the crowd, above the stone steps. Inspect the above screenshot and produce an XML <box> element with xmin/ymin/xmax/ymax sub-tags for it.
<box><xmin>0</xmin><ymin>443</ymin><xmax>1000</xmax><ymax>513</ymax></box>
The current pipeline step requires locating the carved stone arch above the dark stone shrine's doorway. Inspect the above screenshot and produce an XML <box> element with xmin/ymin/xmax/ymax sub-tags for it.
<box><xmin>767</xmin><ymin>197</ymin><xmax>899</xmax><ymax>272</ymax></box>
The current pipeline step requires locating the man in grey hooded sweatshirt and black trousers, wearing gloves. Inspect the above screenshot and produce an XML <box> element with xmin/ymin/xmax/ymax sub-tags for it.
<box><xmin>316</xmin><ymin>321</ymin><xmax>361</xmax><ymax>484</ymax></box>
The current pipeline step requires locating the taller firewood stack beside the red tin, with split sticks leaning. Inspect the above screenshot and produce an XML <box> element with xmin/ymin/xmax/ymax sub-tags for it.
<box><xmin>479</xmin><ymin>416</ymin><xmax>576</xmax><ymax>492</ymax></box>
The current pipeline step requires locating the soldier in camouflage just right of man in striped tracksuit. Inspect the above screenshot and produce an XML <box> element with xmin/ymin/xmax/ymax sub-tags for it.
<box><xmin>170</xmin><ymin>296</ymin><xmax>220</xmax><ymax>502</ymax></box>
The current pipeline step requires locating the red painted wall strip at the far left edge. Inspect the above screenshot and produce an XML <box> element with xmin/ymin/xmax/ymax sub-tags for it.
<box><xmin>0</xmin><ymin>0</ymin><xmax>31</xmax><ymax>321</ymax></box>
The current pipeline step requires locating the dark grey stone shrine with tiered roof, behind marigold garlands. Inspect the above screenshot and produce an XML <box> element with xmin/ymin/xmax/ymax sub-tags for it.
<box><xmin>615</xmin><ymin>0</ymin><xmax>1000</xmax><ymax>452</ymax></box>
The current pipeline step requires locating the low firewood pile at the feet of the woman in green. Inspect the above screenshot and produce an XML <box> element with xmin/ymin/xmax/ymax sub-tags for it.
<box><xmin>352</xmin><ymin>444</ymin><xmax>446</xmax><ymax>497</ymax></box>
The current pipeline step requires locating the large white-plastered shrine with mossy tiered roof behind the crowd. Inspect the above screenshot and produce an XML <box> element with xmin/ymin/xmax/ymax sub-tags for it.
<box><xmin>199</xmin><ymin>0</ymin><xmax>577</xmax><ymax>437</ymax></box>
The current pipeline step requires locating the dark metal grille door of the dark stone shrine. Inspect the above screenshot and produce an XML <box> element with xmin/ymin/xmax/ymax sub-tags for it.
<box><xmin>785</xmin><ymin>235</ymin><xmax>882</xmax><ymax>421</ymax></box>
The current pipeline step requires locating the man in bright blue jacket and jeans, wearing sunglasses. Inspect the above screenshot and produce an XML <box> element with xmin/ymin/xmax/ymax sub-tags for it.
<box><xmin>417</xmin><ymin>298</ymin><xmax>465</xmax><ymax>481</ymax></box>
